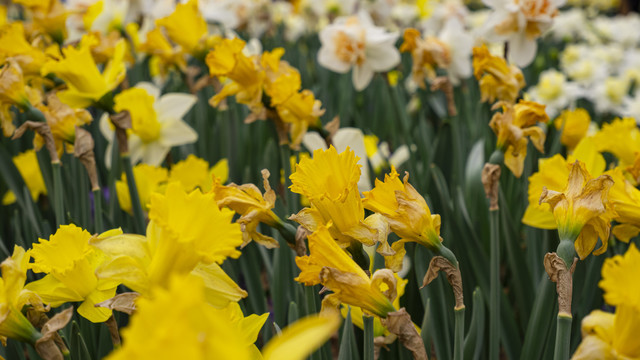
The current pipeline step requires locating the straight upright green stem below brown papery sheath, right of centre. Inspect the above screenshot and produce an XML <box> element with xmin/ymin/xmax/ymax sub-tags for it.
<box><xmin>489</xmin><ymin>209</ymin><xmax>501</xmax><ymax>360</ymax></box>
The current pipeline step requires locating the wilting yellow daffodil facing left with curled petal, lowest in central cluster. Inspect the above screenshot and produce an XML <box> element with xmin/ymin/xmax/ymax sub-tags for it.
<box><xmin>295</xmin><ymin>225</ymin><xmax>396</xmax><ymax>318</ymax></box>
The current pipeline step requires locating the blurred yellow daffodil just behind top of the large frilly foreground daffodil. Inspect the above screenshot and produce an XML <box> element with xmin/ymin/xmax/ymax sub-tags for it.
<box><xmin>169</xmin><ymin>154</ymin><xmax>229</xmax><ymax>193</ymax></box>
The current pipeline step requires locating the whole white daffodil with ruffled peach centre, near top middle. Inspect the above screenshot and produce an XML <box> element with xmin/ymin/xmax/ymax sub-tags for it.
<box><xmin>318</xmin><ymin>12</ymin><xmax>400</xmax><ymax>91</ymax></box>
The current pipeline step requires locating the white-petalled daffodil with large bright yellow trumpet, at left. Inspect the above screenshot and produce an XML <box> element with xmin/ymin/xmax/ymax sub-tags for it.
<box><xmin>100</xmin><ymin>83</ymin><xmax>198</xmax><ymax>167</ymax></box>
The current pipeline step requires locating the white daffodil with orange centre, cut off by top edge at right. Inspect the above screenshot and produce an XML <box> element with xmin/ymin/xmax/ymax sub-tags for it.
<box><xmin>483</xmin><ymin>0</ymin><xmax>565</xmax><ymax>67</ymax></box>
